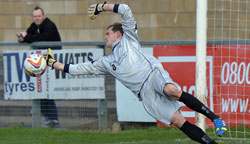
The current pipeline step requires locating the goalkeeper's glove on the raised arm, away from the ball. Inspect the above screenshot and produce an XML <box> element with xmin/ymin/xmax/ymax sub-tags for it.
<box><xmin>88</xmin><ymin>1</ymin><xmax>106</xmax><ymax>20</ymax></box>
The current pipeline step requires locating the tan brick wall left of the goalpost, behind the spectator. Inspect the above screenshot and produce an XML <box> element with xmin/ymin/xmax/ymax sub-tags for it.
<box><xmin>0</xmin><ymin>0</ymin><xmax>196</xmax><ymax>42</ymax></box>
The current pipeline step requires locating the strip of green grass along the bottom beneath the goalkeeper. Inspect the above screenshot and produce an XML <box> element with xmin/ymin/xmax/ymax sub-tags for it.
<box><xmin>0</xmin><ymin>126</ymin><xmax>250</xmax><ymax>144</ymax></box>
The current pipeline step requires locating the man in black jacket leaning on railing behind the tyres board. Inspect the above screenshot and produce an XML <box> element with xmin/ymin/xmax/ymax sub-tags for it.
<box><xmin>17</xmin><ymin>6</ymin><xmax>62</xmax><ymax>127</ymax></box>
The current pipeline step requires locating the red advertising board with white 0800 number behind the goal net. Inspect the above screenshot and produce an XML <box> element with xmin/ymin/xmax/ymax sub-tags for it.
<box><xmin>153</xmin><ymin>45</ymin><xmax>250</xmax><ymax>126</ymax></box>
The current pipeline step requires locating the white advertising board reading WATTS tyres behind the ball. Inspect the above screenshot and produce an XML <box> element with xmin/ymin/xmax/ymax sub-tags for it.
<box><xmin>3</xmin><ymin>49</ymin><xmax>105</xmax><ymax>99</ymax></box>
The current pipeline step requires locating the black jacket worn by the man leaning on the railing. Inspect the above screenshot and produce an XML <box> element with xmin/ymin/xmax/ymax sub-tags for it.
<box><xmin>24</xmin><ymin>18</ymin><xmax>62</xmax><ymax>49</ymax></box>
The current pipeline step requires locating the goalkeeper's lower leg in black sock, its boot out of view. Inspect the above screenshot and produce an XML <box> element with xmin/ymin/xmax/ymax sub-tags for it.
<box><xmin>171</xmin><ymin>111</ymin><xmax>217</xmax><ymax>144</ymax></box>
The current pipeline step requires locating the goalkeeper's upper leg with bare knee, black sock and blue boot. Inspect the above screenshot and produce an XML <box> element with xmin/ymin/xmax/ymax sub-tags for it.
<box><xmin>163</xmin><ymin>83</ymin><xmax>227</xmax><ymax>136</ymax></box>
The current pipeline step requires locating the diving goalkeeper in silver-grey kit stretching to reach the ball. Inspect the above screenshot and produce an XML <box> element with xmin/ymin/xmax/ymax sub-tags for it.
<box><xmin>46</xmin><ymin>3</ymin><xmax>227</xmax><ymax>144</ymax></box>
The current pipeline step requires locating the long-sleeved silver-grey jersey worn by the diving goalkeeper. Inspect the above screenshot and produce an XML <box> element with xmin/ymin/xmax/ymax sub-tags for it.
<box><xmin>65</xmin><ymin>4</ymin><xmax>162</xmax><ymax>95</ymax></box>
